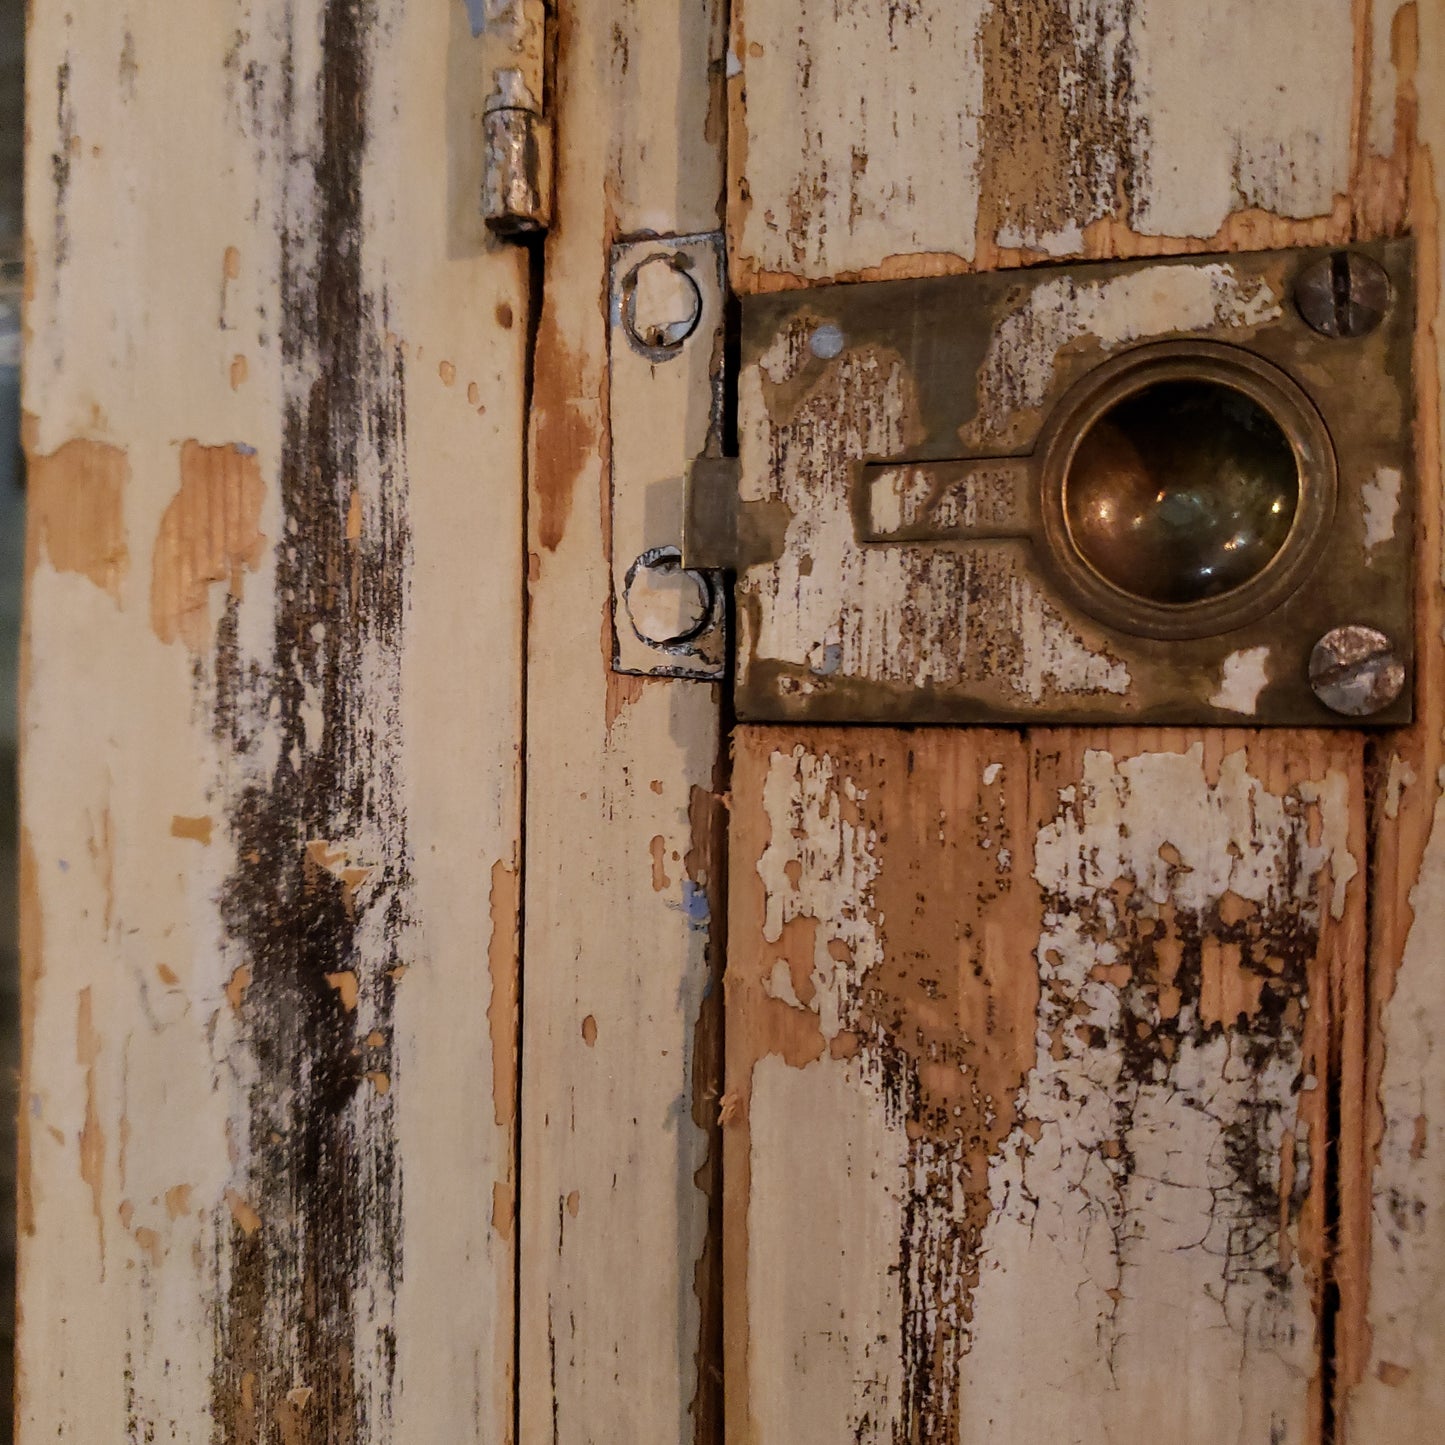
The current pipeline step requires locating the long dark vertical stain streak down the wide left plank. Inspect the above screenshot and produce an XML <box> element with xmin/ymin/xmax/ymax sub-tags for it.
<box><xmin>211</xmin><ymin>0</ymin><xmax>410</xmax><ymax>1445</ymax></box>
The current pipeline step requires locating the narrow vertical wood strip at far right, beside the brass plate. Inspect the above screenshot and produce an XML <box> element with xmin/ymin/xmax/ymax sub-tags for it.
<box><xmin>1338</xmin><ymin>6</ymin><xmax>1445</xmax><ymax>1445</ymax></box>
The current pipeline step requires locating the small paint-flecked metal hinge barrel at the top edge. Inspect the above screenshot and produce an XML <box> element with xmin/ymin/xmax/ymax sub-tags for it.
<box><xmin>481</xmin><ymin>0</ymin><xmax>552</xmax><ymax>237</ymax></box>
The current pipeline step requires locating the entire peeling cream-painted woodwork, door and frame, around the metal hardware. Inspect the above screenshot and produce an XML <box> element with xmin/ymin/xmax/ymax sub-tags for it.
<box><xmin>17</xmin><ymin>0</ymin><xmax>1445</xmax><ymax>1445</ymax></box>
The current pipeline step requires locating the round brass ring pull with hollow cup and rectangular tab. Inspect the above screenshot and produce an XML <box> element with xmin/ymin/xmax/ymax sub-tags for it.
<box><xmin>857</xmin><ymin>341</ymin><xmax>1337</xmax><ymax>637</ymax></box>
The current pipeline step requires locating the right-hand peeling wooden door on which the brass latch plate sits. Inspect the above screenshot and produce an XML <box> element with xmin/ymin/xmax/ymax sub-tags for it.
<box><xmin>723</xmin><ymin>11</ymin><xmax>1442</xmax><ymax>1445</ymax></box>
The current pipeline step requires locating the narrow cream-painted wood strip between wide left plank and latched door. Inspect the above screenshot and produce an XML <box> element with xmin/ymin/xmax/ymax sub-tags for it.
<box><xmin>520</xmin><ymin>0</ymin><xmax>734</xmax><ymax>1445</ymax></box>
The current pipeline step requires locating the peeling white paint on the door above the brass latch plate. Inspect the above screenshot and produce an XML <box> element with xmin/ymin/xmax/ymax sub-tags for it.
<box><xmin>731</xmin><ymin>0</ymin><xmax>1358</xmax><ymax>279</ymax></box>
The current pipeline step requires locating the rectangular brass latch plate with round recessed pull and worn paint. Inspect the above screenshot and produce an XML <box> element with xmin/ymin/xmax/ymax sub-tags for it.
<box><xmin>716</xmin><ymin>241</ymin><xmax>1415</xmax><ymax>725</ymax></box>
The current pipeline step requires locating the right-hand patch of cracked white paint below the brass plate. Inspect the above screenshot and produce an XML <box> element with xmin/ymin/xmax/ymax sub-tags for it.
<box><xmin>959</xmin><ymin>746</ymin><xmax>1327</xmax><ymax>1445</ymax></box>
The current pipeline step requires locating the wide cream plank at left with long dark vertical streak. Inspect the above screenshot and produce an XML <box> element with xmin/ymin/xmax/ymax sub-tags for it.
<box><xmin>17</xmin><ymin>0</ymin><xmax>527</xmax><ymax>1445</ymax></box>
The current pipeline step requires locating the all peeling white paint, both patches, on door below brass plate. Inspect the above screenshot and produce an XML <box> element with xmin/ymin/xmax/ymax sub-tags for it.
<box><xmin>746</xmin><ymin>744</ymin><xmax>1353</xmax><ymax>1445</ymax></box>
